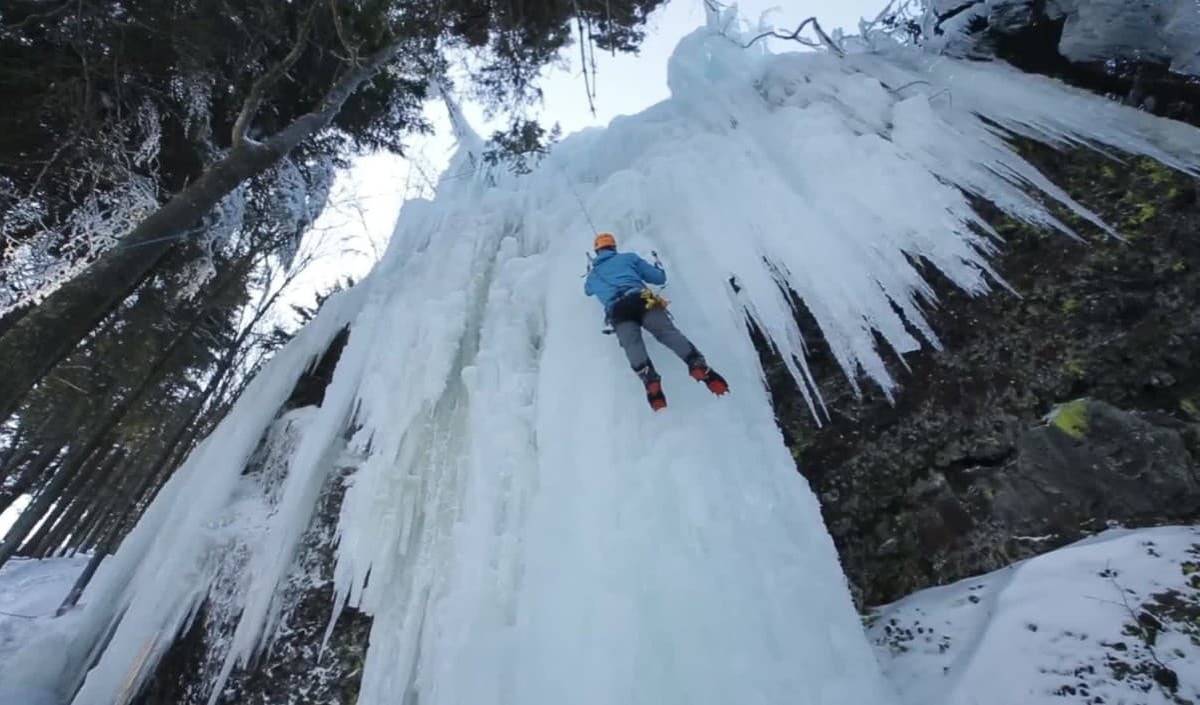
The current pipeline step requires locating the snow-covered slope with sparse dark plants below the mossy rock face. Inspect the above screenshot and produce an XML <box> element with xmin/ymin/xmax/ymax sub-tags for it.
<box><xmin>868</xmin><ymin>526</ymin><xmax>1200</xmax><ymax>705</ymax></box>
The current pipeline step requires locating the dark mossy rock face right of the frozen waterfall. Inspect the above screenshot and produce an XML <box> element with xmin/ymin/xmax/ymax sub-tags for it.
<box><xmin>769</xmin><ymin>146</ymin><xmax>1200</xmax><ymax>604</ymax></box>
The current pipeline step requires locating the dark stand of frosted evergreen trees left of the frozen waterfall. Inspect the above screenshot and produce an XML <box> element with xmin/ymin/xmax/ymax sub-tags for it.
<box><xmin>0</xmin><ymin>0</ymin><xmax>661</xmax><ymax>564</ymax></box>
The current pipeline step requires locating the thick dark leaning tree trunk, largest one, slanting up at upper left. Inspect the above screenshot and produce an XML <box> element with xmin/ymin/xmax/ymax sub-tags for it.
<box><xmin>0</xmin><ymin>42</ymin><xmax>400</xmax><ymax>421</ymax></box>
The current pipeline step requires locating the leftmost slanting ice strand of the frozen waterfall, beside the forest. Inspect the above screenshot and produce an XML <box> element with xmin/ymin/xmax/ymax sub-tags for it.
<box><xmin>60</xmin><ymin>289</ymin><xmax>365</xmax><ymax>705</ymax></box>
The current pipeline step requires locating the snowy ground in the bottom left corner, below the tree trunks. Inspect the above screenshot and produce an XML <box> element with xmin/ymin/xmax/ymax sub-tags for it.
<box><xmin>0</xmin><ymin>555</ymin><xmax>89</xmax><ymax>705</ymax></box>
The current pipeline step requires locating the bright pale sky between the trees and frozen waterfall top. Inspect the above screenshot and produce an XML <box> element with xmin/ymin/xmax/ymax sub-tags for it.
<box><xmin>278</xmin><ymin>0</ymin><xmax>887</xmax><ymax>314</ymax></box>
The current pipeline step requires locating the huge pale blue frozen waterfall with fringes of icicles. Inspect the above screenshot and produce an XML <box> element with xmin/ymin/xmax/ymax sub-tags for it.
<box><xmin>0</xmin><ymin>8</ymin><xmax>1200</xmax><ymax>705</ymax></box>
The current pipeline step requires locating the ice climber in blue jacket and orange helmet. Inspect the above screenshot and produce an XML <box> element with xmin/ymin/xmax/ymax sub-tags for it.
<box><xmin>583</xmin><ymin>233</ymin><xmax>730</xmax><ymax>411</ymax></box>
